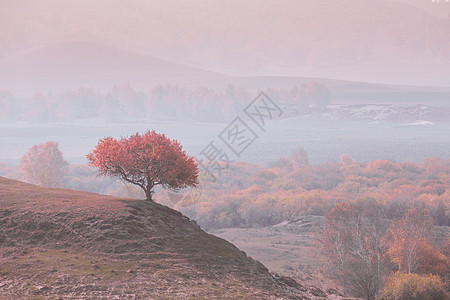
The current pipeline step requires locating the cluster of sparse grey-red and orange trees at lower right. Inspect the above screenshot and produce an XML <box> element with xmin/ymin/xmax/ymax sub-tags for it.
<box><xmin>315</xmin><ymin>204</ymin><xmax>449</xmax><ymax>300</ymax></box>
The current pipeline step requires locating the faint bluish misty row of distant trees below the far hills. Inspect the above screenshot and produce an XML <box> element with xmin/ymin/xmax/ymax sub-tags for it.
<box><xmin>0</xmin><ymin>81</ymin><xmax>331</xmax><ymax>123</ymax></box>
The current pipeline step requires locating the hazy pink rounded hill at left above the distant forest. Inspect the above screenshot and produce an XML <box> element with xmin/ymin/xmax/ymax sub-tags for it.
<box><xmin>0</xmin><ymin>41</ymin><xmax>227</xmax><ymax>91</ymax></box>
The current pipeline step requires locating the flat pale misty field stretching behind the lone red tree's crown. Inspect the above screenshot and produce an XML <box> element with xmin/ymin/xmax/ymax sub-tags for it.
<box><xmin>0</xmin><ymin>110</ymin><xmax>450</xmax><ymax>164</ymax></box>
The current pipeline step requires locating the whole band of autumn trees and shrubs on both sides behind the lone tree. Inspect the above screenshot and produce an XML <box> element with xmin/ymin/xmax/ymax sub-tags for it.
<box><xmin>0</xmin><ymin>142</ymin><xmax>450</xmax><ymax>229</ymax></box>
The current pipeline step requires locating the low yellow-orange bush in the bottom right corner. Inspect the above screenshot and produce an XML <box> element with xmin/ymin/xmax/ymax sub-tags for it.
<box><xmin>377</xmin><ymin>272</ymin><xmax>449</xmax><ymax>300</ymax></box>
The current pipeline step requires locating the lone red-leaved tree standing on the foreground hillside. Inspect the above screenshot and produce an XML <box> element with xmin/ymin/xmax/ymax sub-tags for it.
<box><xmin>86</xmin><ymin>131</ymin><xmax>198</xmax><ymax>201</ymax></box>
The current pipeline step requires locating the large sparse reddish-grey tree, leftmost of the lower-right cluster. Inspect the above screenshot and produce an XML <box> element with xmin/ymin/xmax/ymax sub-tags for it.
<box><xmin>316</xmin><ymin>198</ymin><xmax>388</xmax><ymax>300</ymax></box>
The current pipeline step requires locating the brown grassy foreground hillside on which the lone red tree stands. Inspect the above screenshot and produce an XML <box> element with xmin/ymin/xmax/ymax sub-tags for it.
<box><xmin>0</xmin><ymin>177</ymin><xmax>337</xmax><ymax>299</ymax></box>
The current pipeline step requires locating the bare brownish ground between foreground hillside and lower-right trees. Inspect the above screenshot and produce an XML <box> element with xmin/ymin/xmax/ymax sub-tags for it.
<box><xmin>211</xmin><ymin>216</ymin><xmax>326</xmax><ymax>289</ymax></box>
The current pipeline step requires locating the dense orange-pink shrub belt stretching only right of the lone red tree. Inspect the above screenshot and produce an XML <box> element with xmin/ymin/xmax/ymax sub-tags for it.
<box><xmin>177</xmin><ymin>155</ymin><xmax>450</xmax><ymax>229</ymax></box>
